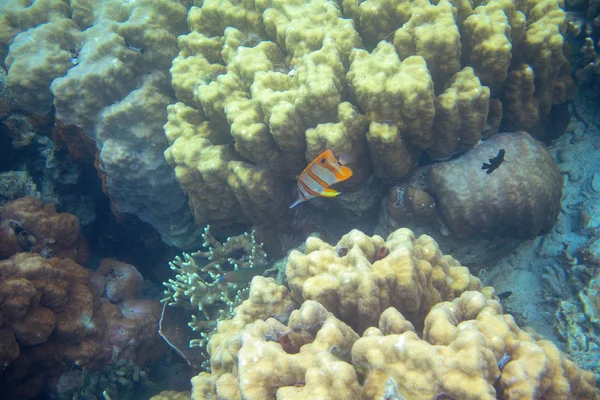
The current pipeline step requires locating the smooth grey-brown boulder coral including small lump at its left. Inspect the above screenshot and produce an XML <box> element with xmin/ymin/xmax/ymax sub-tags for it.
<box><xmin>379</xmin><ymin>132</ymin><xmax>563</xmax><ymax>238</ymax></box>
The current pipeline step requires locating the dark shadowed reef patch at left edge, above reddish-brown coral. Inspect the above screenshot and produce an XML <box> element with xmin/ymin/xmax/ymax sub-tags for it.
<box><xmin>0</xmin><ymin>67</ymin><xmax>100</xmax><ymax>233</ymax></box>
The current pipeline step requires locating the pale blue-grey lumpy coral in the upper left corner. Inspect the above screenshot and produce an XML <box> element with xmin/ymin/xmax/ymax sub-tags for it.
<box><xmin>0</xmin><ymin>0</ymin><xmax>200</xmax><ymax>248</ymax></box>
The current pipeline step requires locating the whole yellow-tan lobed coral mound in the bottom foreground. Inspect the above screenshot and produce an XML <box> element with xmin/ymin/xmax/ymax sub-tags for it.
<box><xmin>192</xmin><ymin>229</ymin><xmax>600</xmax><ymax>400</ymax></box>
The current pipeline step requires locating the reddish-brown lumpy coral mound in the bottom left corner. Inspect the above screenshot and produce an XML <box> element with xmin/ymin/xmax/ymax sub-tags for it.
<box><xmin>0</xmin><ymin>253</ymin><xmax>164</xmax><ymax>399</ymax></box>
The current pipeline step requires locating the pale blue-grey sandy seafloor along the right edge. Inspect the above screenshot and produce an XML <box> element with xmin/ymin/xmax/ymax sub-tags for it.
<box><xmin>483</xmin><ymin>91</ymin><xmax>600</xmax><ymax>372</ymax></box>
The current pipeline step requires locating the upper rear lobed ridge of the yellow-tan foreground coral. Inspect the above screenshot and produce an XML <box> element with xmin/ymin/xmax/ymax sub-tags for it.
<box><xmin>286</xmin><ymin>229</ymin><xmax>482</xmax><ymax>331</ymax></box>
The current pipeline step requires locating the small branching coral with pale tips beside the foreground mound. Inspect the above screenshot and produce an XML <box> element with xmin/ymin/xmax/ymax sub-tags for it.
<box><xmin>160</xmin><ymin>226</ymin><xmax>269</xmax><ymax>362</ymax></box>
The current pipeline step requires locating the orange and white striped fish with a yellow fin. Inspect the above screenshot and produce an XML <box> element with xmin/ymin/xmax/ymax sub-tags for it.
<box><xmin>290</xmin><ymin>149</ymin><xmax>352</xmax><ymax>208</ymax></box>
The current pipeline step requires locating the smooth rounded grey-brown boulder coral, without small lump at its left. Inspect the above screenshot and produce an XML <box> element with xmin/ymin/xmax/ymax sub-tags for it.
<box><xmin>428</xmin><ymin>132</ymin><xmax>563</xmax><ymax>238</ymax></box>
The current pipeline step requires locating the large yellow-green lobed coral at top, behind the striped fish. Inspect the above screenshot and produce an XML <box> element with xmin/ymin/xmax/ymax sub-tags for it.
<box><xmin>165</xmin><ymin>0</ymin><xmax>570</xmax><ymax>231</ymax></box>
